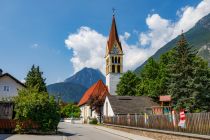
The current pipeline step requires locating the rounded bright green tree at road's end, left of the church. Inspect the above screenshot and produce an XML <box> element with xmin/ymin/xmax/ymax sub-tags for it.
<box><xmin>61</xmin><ymin>103</ymin><xmax>81</xmax><ymax>118</ymax></box>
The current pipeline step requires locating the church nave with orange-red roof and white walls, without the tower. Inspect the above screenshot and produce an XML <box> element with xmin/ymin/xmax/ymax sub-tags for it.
<box><xmin>78</xmin><ymin>80</ymin><xmax>109</xmax><ymax>123</ymax></box>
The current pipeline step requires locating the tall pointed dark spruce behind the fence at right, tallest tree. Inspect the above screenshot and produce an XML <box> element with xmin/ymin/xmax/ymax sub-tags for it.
<box><xmin>167</xmin><ymin>34</ymin><xmax>196</xmax><ymax>111</ymax></box>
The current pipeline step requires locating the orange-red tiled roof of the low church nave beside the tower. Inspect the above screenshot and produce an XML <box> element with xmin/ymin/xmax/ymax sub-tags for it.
<box><xmin>78</xmin><ymin>80</ymin><xmax>109</xmax><ymax>106</ymax></box>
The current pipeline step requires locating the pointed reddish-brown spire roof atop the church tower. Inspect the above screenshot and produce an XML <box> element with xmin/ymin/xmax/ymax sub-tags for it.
<box><xmin>107</xmin><ymin>15</ymin><xmax>122</xmax><ymax>53</ymax></box>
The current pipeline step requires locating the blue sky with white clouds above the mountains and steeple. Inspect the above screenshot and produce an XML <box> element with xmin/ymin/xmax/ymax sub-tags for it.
<box><xmin>0</xmin><ymin>0</ymin><xmax>210</xmax><ymax>84</ymax></box>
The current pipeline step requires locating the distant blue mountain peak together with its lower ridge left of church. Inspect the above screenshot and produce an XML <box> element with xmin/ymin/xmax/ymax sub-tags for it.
<box><xmin>47</xmin><ymin>68</ymin><xmax>105</xmax><ymax>102</ymax></box>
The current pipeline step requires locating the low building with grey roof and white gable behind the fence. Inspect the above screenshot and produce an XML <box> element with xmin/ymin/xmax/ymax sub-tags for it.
<box><xmin>103</xmin><ymin>95</ymin><xmax>159</xmax><ymax>117</ymax></box>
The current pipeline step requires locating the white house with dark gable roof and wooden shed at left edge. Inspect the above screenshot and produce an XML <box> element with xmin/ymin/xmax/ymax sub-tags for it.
<box><xmin>0</xmin><ymin>69</ymin><xmax>25</xmax><ymax>119</ymax></box>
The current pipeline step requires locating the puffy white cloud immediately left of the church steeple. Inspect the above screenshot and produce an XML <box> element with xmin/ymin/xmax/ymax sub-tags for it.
<box><xmin>65</xmin><ymin>27</ymin><xmax>107</xmax><ymax>72</ymax></box>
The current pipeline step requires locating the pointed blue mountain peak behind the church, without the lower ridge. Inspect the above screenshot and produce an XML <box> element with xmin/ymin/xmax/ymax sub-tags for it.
<box><xmin>65</xmin><ymin>67</ymin><xmax>105</xmax><ymax>88</ymax></box>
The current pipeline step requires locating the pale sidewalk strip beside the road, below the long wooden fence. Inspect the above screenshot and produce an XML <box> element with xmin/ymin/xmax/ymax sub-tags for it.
<box><xmin>95</xmin><ymin>126</ymin><xmax>154</xmax><ymax>140</ymax></box>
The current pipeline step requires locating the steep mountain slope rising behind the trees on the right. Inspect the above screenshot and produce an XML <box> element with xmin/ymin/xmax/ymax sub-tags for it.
<box><xmin>134</xmin><ymin>14</ymin><xmax>210</xmax><ymax>74</ymax></box>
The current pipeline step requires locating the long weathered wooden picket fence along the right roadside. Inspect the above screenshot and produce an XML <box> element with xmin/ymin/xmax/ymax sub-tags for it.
<box><xmin>104</xmin><ymin>112</ymin><xmax>210</xmax><ymax>135</ymax></box>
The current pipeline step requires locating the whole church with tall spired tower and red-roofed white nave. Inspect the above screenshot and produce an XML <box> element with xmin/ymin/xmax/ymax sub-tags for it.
<box><xmin>78</xmin><ymin>14</ymin><xmax>123</xmax><ymax>123</ymax></box>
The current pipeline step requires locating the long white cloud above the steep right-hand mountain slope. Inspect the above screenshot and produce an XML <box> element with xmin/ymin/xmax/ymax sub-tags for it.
<box><xmin>139</xmin><ymin>0</ymin><xmax>210</xmax><ymax>54</ymax></box>
